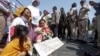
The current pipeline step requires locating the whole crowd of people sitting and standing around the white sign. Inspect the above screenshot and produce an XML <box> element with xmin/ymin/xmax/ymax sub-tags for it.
<box><xmin>0</xmin><ymin>0</ymin><xmax>100</xmax><ymax>56</ymax></box>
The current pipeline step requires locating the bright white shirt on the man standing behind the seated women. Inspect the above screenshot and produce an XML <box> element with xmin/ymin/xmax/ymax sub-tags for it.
<box><xmin>27</xmin><ymin>6</ymin><xmax>40</xmax><ymax>25</ymax></box>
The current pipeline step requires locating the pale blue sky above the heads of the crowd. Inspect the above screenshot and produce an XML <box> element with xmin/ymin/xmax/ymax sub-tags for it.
<box><xmin>11</xmin><ymin>0</ymin><xmax>100</xmax><ymax>20</ymax></box>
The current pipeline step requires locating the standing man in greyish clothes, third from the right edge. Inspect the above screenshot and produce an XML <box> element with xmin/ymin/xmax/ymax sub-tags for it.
<box><xmin>69</xmin><ymin>3</ymin><xmax>77</xmax><ymax>39</ymax></box>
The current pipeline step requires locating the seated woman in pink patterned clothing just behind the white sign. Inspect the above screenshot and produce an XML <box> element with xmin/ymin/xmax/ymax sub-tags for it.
<box><xmin>35</xmin><ymin>19</ymin><xmax>53</xmax><ymax>42</ymax></box>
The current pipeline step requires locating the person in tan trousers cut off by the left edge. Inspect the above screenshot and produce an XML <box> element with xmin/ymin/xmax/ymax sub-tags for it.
<box><xmin>0</xmin><ymin>0</ymin><xmax>10</xmax><ymax>45</ymax></box>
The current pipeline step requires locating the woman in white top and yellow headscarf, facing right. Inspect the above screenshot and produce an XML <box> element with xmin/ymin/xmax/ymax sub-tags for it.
<box><xmin>8</xmin><ymin>8</ymin><xmax>31</xmax><ymax>42</ymax></box>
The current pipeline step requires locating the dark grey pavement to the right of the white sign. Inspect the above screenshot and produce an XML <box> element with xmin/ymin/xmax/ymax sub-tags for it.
<box><xmin>33</xmin><ymin>32</ymin><xmax>97</xmax><ymax>56</ymax></box>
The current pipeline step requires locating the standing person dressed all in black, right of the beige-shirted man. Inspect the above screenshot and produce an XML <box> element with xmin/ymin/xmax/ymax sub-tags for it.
<box><xmin>58</xmin><ymin>8</ymin><xmax>66</xmax><ymax>40</ymax></box>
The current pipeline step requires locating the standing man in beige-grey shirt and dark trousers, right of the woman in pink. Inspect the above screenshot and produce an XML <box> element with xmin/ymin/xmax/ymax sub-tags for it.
<box><xmin>51</xmin><ymin>6</ymin><xmax>60</xmax><ymax>37</ymax></box>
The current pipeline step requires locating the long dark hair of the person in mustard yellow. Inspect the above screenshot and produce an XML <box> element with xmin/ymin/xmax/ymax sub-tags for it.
<box><xmin>11</xmin><ymin>25</ymin><xmax>29</xmax><ymax>51</ymax></box>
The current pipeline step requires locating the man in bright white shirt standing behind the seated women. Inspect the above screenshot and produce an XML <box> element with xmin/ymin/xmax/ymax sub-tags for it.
<box><xmin>27</xmin><ymin>0</ymin><xmax>41</xmax><ymax>25</ymax></box>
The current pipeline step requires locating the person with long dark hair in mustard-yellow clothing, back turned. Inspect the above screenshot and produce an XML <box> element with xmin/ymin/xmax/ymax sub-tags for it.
<box><xmin>0</xmin><ymin>25</ymin><xmax>31</xmax><ymax>56</ymax></box>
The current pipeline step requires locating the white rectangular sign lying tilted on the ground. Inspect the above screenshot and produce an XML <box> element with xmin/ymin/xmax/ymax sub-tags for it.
<box><xmin>34</xmin><ymin>37</ymin><xmax>64</xmax><ymax>56</ymax></box>
